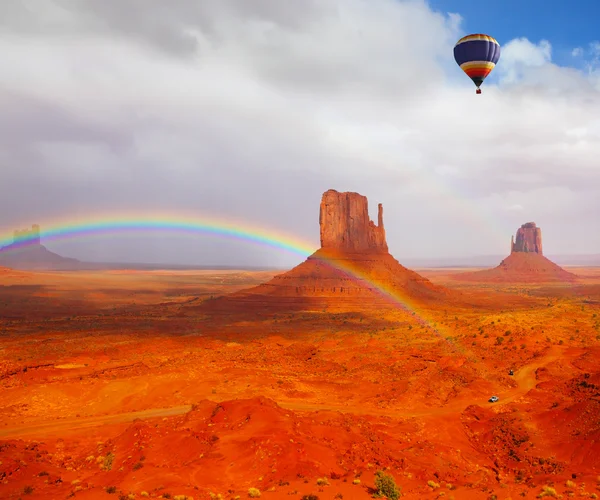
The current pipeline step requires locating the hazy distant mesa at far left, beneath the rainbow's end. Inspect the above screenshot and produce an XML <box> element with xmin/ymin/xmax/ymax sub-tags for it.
<box><xmin>0</xmin><ymin>224</ymin><xmax>81</xmax><ymax>270</ymax></box>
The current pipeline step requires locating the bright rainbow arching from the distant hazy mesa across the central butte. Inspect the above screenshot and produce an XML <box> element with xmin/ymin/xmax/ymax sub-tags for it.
<box><xmin>0</xmin><ymin>213</ymin><xmax>462</xmax><ymax>358</ymax></box>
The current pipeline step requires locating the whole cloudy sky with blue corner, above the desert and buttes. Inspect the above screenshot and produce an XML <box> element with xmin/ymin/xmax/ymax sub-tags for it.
<box><xmin>0</xmin><ymin>0</ymin><xmax>600</xmax><ymax>266</ymax></box>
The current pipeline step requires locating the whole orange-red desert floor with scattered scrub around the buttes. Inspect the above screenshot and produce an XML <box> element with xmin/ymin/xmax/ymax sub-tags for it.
<box><xmin>0</xmin><ymin>268</ymin><xmax>600</xmax><ymax>500</ymax></box>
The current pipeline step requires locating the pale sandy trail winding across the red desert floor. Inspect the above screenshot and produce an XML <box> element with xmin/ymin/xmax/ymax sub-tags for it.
<box><xmin>0</xmin><ymin>346</ymin><xmax>563</xmax><ymax>438</ymax></box>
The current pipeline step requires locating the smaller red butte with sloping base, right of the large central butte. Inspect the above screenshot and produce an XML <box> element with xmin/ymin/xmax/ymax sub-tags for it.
<box><xmin>453</xmin><ymin>222</ymin><xmax>577</xmax><ymax>283</ymax></box>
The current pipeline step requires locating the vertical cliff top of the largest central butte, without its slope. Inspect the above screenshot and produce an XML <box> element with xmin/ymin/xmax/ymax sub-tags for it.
<box><xmin>319</xmin><ymin>189</ymin><xmax>388</xmax><ymax>253</ymax></box>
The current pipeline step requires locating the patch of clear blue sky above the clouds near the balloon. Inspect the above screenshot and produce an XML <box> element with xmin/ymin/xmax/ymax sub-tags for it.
<box><xmin>428</xmin><ymin>0</ymin><xmax>600</xmax><ymax>67</ymax></box>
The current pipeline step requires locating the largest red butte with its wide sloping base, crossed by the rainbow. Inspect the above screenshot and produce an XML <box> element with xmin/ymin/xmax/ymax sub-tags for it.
<box><xmin>201</xmin><ymin>189</ymin><xmax>452</xmax><ymax>312</ymax></box>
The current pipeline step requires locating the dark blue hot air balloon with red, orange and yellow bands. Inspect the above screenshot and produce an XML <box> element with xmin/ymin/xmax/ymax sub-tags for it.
<box><xmin>454</xmin><ymin>34</ymin><xmax>500</xmax><ymax>94</ymax></box>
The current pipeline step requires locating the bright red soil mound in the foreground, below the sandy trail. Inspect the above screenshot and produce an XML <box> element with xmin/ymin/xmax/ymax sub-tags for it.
<box><xmin>2</xmin><ymin>397</ymin><xmax>429</xmax><ymax>498</ymax></box>
